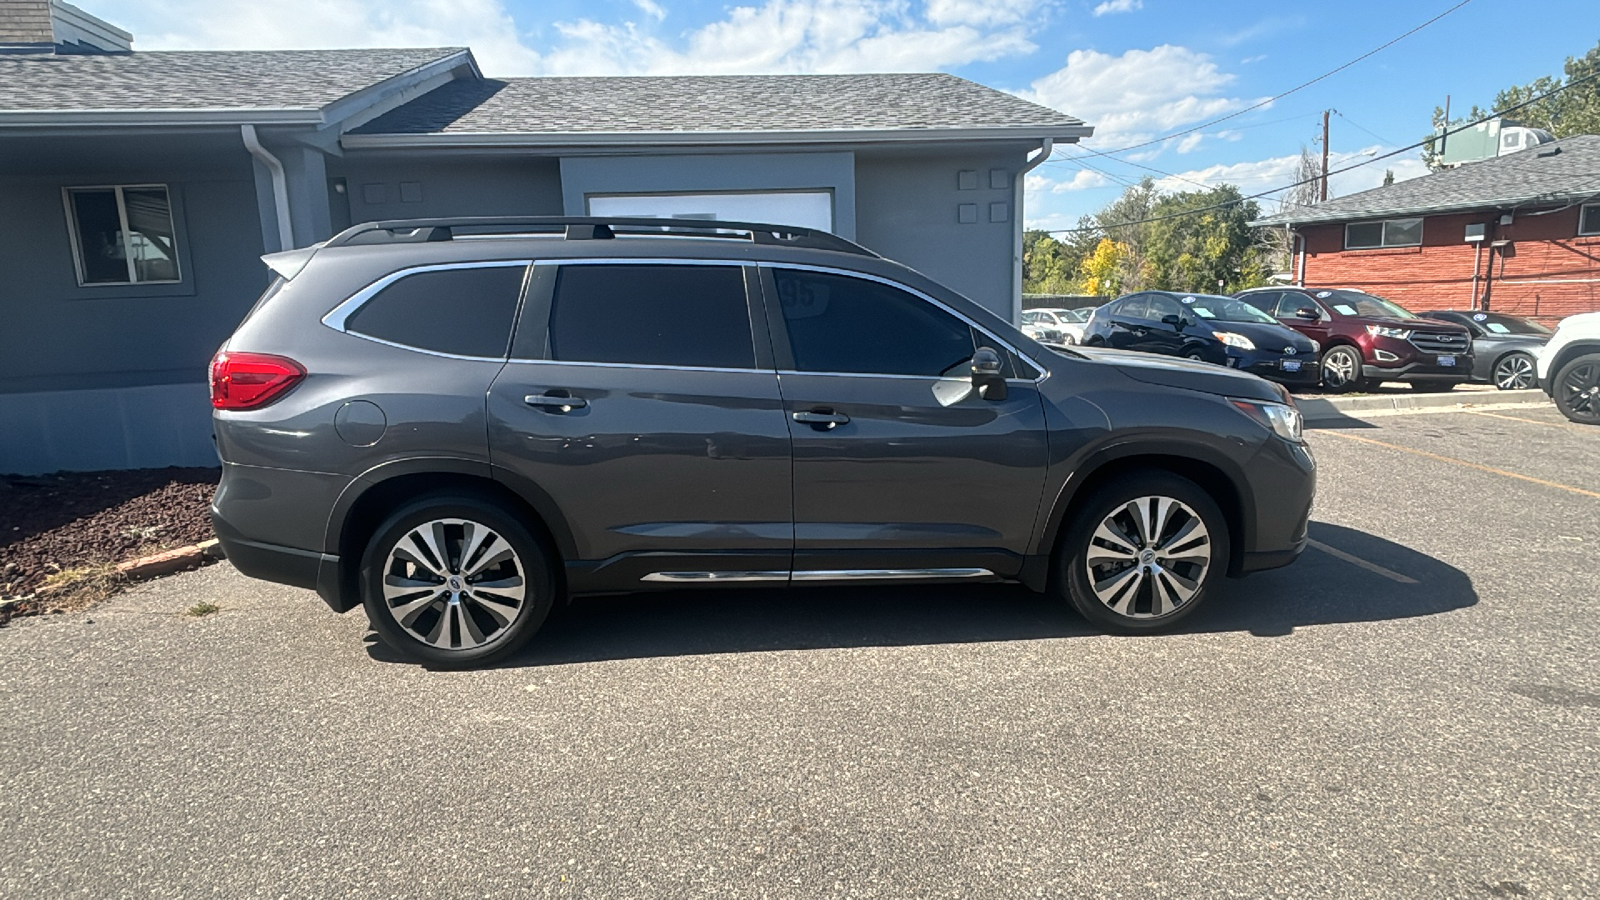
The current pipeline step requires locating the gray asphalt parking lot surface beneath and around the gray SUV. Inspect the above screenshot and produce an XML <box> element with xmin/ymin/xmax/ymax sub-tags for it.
<box><xmin>0</xmin><ymin>407</ymin><xmax>1600</xmax><ymax>898</ymax></box>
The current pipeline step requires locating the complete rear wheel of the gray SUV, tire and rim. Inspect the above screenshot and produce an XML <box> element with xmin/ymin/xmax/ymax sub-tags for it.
<box><xmin>360</xmin><ymin>493</ymin><xmax>557</xmax><ymax>668</ymax></box>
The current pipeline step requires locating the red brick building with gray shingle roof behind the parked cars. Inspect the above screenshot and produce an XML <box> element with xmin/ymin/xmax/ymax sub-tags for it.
<box><xmin>1254</xmin><ymin>135</ymin><xmax>1600</xmax><ymax>322</ymax></box>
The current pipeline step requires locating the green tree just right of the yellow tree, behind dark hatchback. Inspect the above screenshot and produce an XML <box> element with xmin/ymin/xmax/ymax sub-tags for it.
<box><xmin>1146</xmin><ymin>184</ymin><xmax>1269</xmax><ymax>293</ymax></box>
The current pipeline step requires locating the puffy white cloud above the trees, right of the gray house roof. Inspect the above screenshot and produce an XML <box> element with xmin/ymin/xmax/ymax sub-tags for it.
<box><xmin>1021</xmin><ymin>43</ymin><xmax>1250</xmax><ymax>149</ymax></box>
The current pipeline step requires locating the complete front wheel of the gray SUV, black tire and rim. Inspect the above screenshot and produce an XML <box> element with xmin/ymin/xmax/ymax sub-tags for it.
<box><xmin>1054</xmin><ymin>471</ymin><xmax>1230</xmax><ymax>634</ymax></box>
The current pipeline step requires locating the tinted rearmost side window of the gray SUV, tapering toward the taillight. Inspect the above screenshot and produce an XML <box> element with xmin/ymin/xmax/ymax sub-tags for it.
<box><xmin>346</xmin><ymin>264</ymin><xmax>526</xmax><ymax>359</ymax></box>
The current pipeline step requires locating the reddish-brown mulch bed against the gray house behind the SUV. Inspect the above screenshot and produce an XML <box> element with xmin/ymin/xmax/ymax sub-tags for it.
<box><xmin>0</xmin><ymin>468</ymin><xmax>221</xmax><ymax>614</ymax></box>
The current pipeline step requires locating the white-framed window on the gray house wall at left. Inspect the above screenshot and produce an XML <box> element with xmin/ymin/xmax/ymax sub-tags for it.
<box><xmin>64</xmin><ymin>184</ymin><xmax>181</xmax><ymax>285</ymax></box>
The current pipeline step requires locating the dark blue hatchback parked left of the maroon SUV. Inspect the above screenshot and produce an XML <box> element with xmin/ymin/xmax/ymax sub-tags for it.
<box><xmin>1083</xmin><ymin>290</ymin><xmax>1318</xmax><ymax>384</ymax></box>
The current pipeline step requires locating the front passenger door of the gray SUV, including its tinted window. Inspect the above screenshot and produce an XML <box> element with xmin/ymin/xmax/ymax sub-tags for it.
<box><xmin>762</xmin><ymin>264</ymin><xmax>1046</xmax><ymax>581</ymax></box>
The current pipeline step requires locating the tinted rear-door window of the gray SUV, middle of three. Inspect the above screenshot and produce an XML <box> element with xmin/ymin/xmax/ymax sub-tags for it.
<box><xmin>550</xmin><ymin>266</ymin><xmax>755</xmax><ymax>368</ymax></box>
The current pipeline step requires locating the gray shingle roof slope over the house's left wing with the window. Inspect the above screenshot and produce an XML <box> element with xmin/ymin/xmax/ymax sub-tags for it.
<box><xmin>0</xmin><ymin>48</ymin><xmax>461</xmax><ymax>114</ymax></box>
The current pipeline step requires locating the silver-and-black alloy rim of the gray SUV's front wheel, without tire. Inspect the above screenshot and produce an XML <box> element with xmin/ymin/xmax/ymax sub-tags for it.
<box><xmin>1083</xmin><ymin>496</ymin><xmax>1211</xmax><ymax>618</ymax></box>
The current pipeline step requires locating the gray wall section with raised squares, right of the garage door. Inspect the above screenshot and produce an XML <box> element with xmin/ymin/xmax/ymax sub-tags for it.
<box><xmin>856</xmin><ymin>149</ymin><xmax>1026</xmax><ymax>319</ymax></box>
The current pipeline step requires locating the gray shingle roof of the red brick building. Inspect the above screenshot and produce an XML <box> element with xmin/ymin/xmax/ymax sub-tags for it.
<box><xmin>1254</xmin><ymin>135</ymin><xmax>1600</xmax><ymax>224</ymax></box>
